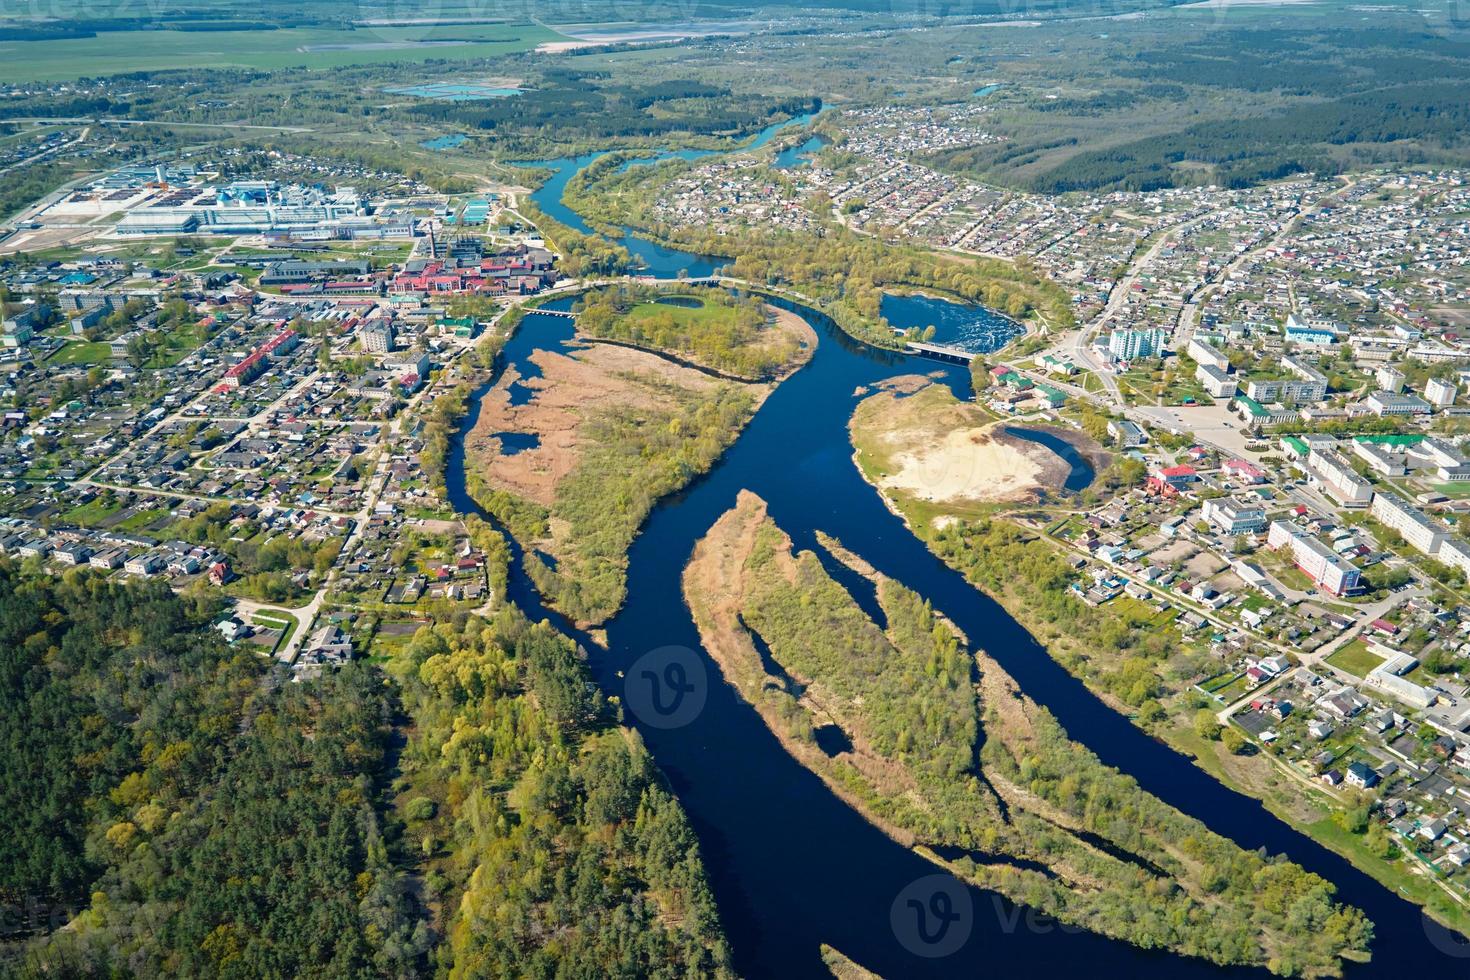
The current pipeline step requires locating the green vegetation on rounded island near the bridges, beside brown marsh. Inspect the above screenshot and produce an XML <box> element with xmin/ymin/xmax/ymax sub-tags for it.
<box><xmin>467</xmin><ymin>287</ymin><xmax>810</xmax><ymax>624</ymax></box>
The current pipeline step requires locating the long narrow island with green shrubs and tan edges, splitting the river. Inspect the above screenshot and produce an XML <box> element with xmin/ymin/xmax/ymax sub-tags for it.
<box><xmin>685</xmin><ymin>492</ymin><xmax>1372</xmax><ymax>976</ymax></box>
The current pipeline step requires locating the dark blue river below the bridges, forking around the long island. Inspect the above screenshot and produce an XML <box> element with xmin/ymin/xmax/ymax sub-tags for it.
<box><xmin>447</xmin><ymin>300</ymin><xmax>1467</xmax><ymax>980</ymax></box>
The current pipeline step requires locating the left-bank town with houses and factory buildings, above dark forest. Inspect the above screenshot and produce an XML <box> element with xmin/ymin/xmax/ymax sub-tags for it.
<box><xmin>0</xmin><ymin>151</ymin><xmax>557</xmax><ymax>679</ymax></box>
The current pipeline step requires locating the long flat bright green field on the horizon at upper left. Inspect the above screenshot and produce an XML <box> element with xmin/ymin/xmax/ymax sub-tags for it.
<box><xmin>0</xmin><ymin>24</ymin><xmax>564</xmax><ymax>82</ymax></box>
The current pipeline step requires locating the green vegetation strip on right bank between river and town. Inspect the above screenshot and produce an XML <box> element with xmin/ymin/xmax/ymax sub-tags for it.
<box><xmin>850</xmin><ymin>378</ymin><xmax>1467</xmax><ymax>930</ymax></box>
